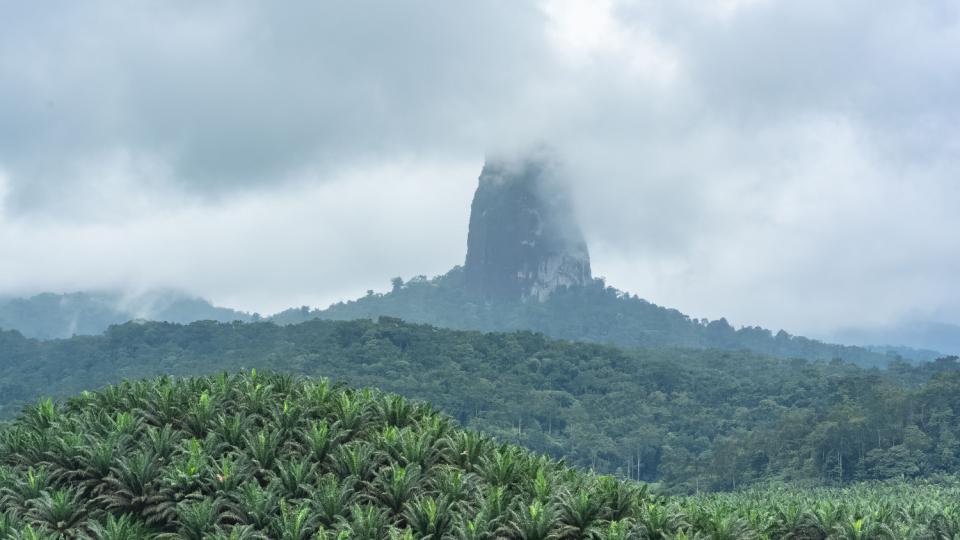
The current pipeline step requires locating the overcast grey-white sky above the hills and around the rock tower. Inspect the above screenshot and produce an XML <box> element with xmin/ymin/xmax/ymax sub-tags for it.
<box><xmin>0</xmin><ymin>0</ymin><xmax>960</xmax><ymax>334</ymax></box>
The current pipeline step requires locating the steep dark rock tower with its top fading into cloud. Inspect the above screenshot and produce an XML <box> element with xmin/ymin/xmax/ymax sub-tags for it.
<box><xmin>464</xmin><ymin>154</ymin><xmax>591</xmax><ymax>301</ymax></box>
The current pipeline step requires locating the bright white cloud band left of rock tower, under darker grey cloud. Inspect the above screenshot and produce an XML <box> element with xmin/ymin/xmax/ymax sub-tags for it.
<box><xmin>0</xmin><ymin>157</ymin><xmax>481</xmax><ymax>313</ymax></box>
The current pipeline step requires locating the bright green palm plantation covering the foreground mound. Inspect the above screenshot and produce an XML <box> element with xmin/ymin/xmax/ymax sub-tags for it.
<box><xmin>0</xmin><ymin>373</ymin><xmax>960</xmax><ymax>540</ymax></box>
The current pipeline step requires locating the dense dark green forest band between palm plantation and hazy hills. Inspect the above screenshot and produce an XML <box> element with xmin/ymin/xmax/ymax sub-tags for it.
<box><xmin>0</xmin><ymin>319</ymin><xmax>960</xmax><ymax>491</ymax></box>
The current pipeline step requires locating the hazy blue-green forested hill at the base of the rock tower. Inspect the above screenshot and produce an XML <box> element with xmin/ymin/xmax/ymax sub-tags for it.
<box><xmin>271</xmin><ymin>267</ymin><xmax>908</xmax><ymax>367</ymax></box>
